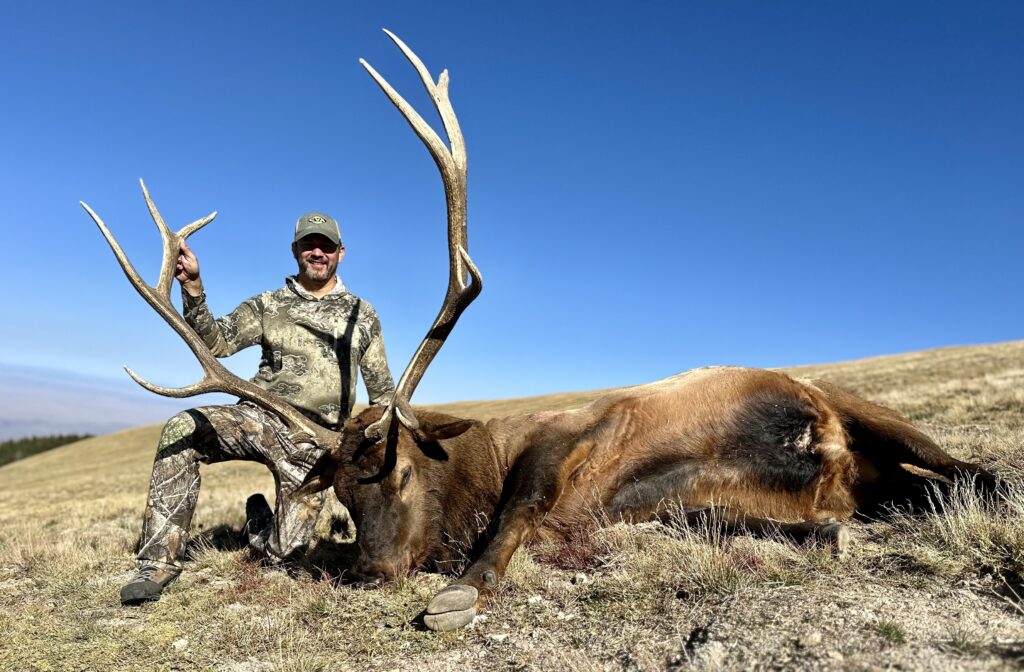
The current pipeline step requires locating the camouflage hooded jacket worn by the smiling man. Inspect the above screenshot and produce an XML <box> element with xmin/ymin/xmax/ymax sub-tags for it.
<box><xmin>181</xmin><ymin>277</ymin><xmax>394</xmax><ymax>427</ymax></box>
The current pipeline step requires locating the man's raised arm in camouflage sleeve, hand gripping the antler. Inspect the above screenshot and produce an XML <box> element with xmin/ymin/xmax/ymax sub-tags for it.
<box><xmin>174</xmin><ymin>241</ymin><xmax>263</xmax><ymax>356</ymax></box>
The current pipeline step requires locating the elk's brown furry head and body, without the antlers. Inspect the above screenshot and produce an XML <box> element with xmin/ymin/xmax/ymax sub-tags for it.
<box><xmin>301</xmin><ymin>368</ymin><xmax>994</xmax><ymax>622</ymax></box>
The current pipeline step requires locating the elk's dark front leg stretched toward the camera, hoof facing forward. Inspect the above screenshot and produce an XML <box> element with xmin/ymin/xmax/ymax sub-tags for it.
<box><xmin>423</xmin><ymin>442</ymin><xmax>594</xmax><ymax>630</ymax></box>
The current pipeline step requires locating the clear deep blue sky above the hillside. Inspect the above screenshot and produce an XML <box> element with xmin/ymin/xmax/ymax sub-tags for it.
<box><xmin>0</xmin><ymin>1</ymin><xmax>1024</xmax><ymax>403</ymax></box>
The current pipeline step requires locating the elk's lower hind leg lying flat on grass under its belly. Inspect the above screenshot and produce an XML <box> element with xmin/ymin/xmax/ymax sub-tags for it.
<box><xmin>660</xmin><ymin>506</ymin><xmax>851</xmax><ymax>557</ymax></box>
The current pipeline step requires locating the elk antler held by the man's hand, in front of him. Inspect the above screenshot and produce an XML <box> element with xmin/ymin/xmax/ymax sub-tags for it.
<box><xmin>80</xmin><ymin>180</ymin><xmax>341</xmax><ymax>450</ymax></box>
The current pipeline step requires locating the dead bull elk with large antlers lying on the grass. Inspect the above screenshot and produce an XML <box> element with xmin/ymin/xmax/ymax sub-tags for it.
<box><xmin>83</xmin><ymin>32</ymin><xmax>996</xmax><ymax>630</ymax></box>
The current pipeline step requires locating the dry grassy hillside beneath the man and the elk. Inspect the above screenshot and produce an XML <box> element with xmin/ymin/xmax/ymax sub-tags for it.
<box><xmin>0</xmin><ymin>342</ymin><xmax>1024</xmax><ymax>672</ymax></box>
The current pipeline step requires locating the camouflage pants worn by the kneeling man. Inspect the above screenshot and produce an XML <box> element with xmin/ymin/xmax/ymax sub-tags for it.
<box><xmin>138</xmin><ymin>403</ymin><xmax>324</xmax><ymax>570</ymax></box>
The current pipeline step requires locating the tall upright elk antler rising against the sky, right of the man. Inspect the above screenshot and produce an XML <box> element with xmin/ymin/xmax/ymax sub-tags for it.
<box><xmin>359</xmin><ymin>29</ymin><xmax>483</xmax><ymax>439</ymax></box>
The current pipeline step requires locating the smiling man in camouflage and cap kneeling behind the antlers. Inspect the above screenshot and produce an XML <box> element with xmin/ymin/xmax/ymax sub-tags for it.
<box><xmin>121</xmin><ymin>212</ymin><xmax>394</xmax><ymax>604</ymax></box>
